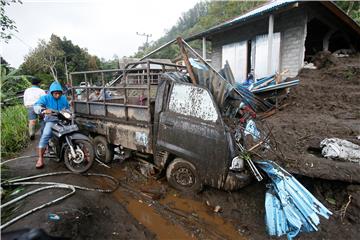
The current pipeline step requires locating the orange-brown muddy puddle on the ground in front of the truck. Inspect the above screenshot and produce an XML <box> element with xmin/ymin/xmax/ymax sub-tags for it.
<box><xmin>104</xmin><ymin>163</ymin><xmax>246</xmax><ymax>239</ymax></box>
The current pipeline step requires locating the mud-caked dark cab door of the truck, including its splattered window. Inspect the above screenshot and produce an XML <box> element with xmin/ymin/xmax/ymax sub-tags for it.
<box><xmin>157</xmin><ymin>83</ymin><xmax>228</xmax><ymax>187</ymax></box>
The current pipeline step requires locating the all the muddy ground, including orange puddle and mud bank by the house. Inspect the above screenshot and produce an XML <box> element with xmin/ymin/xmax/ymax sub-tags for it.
<box><xmin>3</xmin><ymin>54</ymin><xmax>360</xmax><ymax>240</ymax></box>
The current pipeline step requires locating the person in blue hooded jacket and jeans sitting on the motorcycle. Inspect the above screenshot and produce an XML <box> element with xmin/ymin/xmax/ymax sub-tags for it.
<box><xmin>34</xmin><ymin>81</ymin><xmax>70</xmax><ymax>168</ymax></box>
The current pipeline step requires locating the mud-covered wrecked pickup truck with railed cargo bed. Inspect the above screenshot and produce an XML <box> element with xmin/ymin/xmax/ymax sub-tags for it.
<box><xmin>70</xmin><ymin>60</ymin><xmax>251</xmax><ymax>191</ymax></box>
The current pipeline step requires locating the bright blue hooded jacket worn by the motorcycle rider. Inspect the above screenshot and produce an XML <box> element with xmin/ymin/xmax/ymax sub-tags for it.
<box><xmin>34</xmin><ymin>81</ymin><xmax>70</xmax><ymax>122</ymax></box>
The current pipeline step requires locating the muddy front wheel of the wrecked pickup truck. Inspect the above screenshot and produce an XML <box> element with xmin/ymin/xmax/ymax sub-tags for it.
<box><xmin>166</xmin><ymin>158</ymin><xmax>202</xmax><ymax>193</ymax></box>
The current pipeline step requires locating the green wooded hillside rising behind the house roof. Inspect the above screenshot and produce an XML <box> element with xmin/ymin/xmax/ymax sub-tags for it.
<box><xmin>134</xmin><ymin>1</ymin><xmax>264</xmax><ymax>59</ymax></box>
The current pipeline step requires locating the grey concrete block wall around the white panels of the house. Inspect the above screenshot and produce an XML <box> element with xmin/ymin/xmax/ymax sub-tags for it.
<box><xmin>211</xmin><ymin>7</ymin><xmax>307</xmax><ymax>77</ymax></box>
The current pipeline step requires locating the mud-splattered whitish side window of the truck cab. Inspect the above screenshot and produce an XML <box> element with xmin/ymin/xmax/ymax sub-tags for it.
<box><xmin>169</xmin><ymin>83</ymin><xmax>218</xmax><ymax>122</ymax></box>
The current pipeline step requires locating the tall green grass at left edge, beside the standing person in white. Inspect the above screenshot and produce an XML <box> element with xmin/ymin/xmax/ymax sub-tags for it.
<box><xmin>1</xmin><ymin>105</ymin><xmax>29</xmax><ymax>157</ymax></box>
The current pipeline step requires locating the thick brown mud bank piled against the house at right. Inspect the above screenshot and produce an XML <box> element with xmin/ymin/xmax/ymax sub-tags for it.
<box><xmin>266</xmin><ymin>56</ymin><xmax>360</xmax><ymax>183</ymax></box>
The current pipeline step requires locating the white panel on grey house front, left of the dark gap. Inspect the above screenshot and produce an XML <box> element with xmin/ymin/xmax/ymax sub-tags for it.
<box><xmin>222</xmin><ymin>41</ymin><xmax>248</xmax><ymax>83</ymax></box>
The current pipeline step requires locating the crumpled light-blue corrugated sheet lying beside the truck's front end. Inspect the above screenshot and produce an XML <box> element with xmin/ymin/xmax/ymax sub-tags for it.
<box><xmin>256</xmin><ymin>161</ymin><xmax>332</xmax><ymax>239</ymax></box>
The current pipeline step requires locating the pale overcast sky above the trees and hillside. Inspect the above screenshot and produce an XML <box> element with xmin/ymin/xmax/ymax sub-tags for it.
<box><xmin>1</xmin><ymin>0</ymin><xmax>200</xmax><ymax>68</ymax></box>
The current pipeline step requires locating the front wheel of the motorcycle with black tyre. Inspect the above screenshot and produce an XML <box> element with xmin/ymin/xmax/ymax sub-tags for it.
<box><xmin>64</xmin><ymin>140</ymin><xmax>95</xmax><ymax>173</ymax></box>
